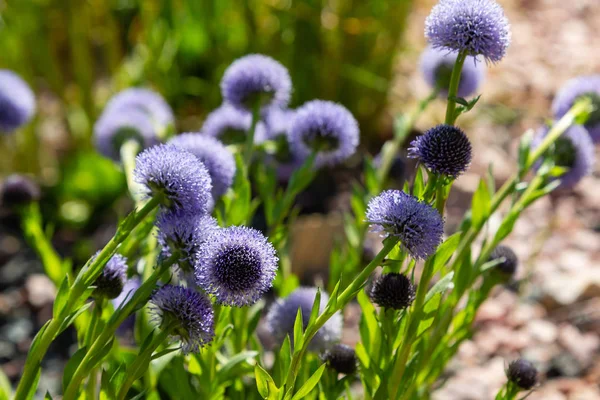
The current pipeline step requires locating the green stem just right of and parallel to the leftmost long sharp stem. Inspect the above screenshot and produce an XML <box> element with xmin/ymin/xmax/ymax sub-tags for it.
<box><xmin>63</xmin><ymin>252</ymin><xmax>181</xmax><ymax>400</ymax></box>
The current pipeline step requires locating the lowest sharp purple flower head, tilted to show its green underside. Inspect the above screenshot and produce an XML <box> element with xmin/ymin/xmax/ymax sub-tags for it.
<box><xmin>150</xmin><ymin>285</ymin><xmax>215</xmax><ymax>354</ymax></box>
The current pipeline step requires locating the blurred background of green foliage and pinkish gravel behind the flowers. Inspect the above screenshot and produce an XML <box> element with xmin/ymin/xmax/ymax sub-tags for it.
<box><xmin>0</xmin><ymin>0</ymin><xmax>600</xmax><ymax>400</ymax></box>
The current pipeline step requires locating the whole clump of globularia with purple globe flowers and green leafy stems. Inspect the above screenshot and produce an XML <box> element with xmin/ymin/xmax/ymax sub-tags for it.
<box><xmin>0</xmin><ymin>0</ymin><xmax>598</xmax><ymax>400</ymax></box>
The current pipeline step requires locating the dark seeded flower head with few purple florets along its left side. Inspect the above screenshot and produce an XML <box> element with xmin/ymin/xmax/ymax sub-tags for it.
<box><xmin>408</xmin><ymin>124</ymin><xmax>472</xmax><ymax>179</ymax></box>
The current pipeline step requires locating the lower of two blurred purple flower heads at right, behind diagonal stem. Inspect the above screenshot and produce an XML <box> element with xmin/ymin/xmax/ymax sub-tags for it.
<box><xmin>532</xmin><ymin>125</ymin><xmax>596</xmax><ymax>190</ymax></box>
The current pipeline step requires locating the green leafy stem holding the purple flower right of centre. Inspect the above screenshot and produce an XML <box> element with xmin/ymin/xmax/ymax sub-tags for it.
<box><xmin>284</xmin><ymin>237</ymin><xmax>398</xmax><ymax>399</ymax></box>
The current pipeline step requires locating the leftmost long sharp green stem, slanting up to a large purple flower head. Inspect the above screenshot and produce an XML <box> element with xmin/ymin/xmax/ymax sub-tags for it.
<box><xmin>15</xmin><ymin>198</ymin><xmax>160</xmax><ymax>400</ymax></box>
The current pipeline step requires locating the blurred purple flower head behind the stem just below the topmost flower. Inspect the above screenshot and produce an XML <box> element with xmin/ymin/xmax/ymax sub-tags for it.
<box><xmin>421</xmin><ymin>46</ymin><xmax>485</xmax><ymax>97</ymax></box>
